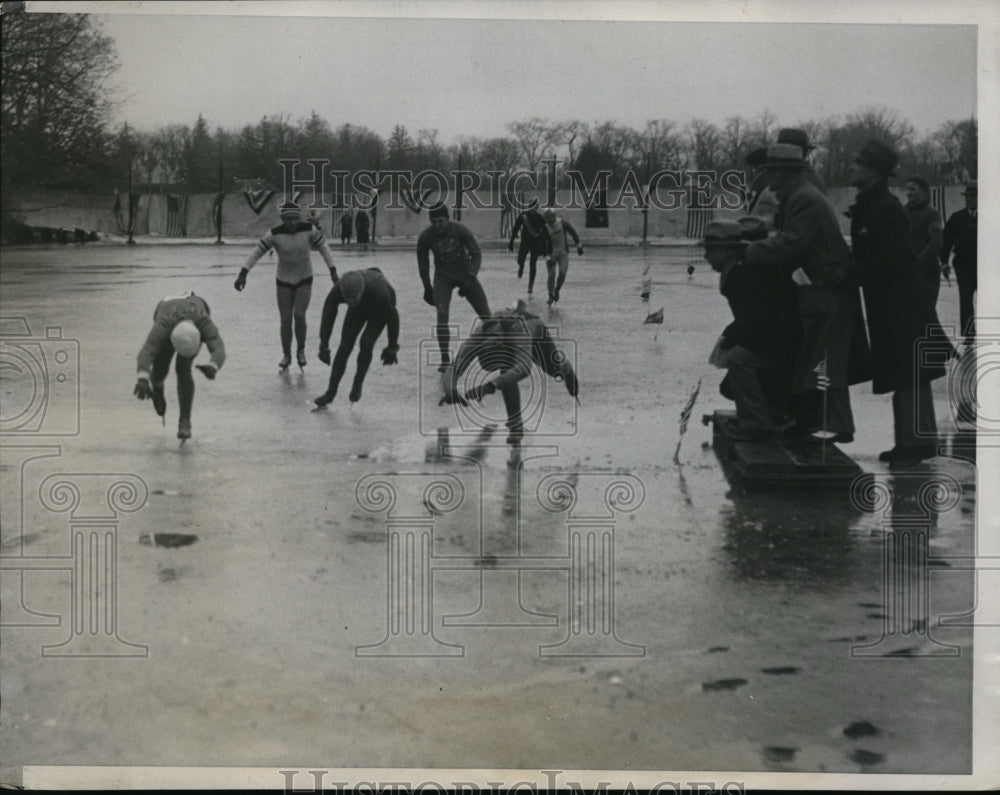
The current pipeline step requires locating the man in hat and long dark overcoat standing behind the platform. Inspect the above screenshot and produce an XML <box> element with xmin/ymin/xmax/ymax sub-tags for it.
<box><xmin>848</xmin><ymin>140</ymin><xmax>945</xmax><ymax>465</ymax></box>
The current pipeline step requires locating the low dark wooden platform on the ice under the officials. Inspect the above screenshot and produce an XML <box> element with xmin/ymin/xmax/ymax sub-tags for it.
<box><xmin>702</xmin><ymin>411</ymin><xmax>864</xmax><ymax>492</ymax></box>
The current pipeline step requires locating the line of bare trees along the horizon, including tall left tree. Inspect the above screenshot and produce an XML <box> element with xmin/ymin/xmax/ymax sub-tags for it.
<box><xmin>0</xmin><ymin>14</ymin><xmax>978</xmax><ymax>204</ymax></box>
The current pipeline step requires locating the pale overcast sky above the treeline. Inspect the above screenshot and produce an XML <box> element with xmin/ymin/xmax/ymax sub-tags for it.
<box><xmin>77</xmin><ymin>3</ymin><xmax>976</xmax><ymax>144</ymax></box>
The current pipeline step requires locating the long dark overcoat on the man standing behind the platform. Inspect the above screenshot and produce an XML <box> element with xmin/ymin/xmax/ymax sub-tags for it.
<box><xmin>848</xmin><ymin>180</ymin><xmax>946</xmax><ymax>394</ymax></box>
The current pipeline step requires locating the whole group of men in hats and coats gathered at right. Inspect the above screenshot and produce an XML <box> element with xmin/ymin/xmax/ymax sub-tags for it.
<box><xmin>702</xmin><ymin>129</ymin><xmax>977</xmax><ymax>465</ymax></box>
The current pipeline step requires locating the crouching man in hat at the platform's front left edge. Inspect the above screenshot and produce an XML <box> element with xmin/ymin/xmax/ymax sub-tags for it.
<box><xmin>701</xmin><ymin>218</ymin><xmax>794</xmax><ymax>441</ymax></box>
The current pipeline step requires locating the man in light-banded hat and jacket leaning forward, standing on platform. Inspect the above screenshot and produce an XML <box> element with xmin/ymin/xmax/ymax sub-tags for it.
<box><xmin>746</xmin><ymin>144</ymin><xmax>870</xmax><ymax>443</ymax></box>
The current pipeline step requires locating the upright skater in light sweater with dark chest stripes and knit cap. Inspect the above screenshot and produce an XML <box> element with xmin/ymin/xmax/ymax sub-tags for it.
<box><xmin>233</xmin><ymin>202</ymin><xmax>337</xmax><ymax>370</ymax></box>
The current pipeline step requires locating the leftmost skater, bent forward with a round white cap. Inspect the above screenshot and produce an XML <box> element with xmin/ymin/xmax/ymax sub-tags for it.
<box><xmin>133</xmin><ymin>292</ymin><xmax>226</xmax><ymax>441</ymax></box>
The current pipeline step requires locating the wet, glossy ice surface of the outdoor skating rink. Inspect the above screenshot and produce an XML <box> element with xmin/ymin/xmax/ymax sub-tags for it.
<box><xmin>0</xmin><ymin>241</ymin><xmax>975</xmax><ymax>786</ymax></box>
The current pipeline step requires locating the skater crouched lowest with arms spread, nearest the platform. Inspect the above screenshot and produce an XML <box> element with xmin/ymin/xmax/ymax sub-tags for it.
<box><xmin>440</xmin><ymin>301</ymin><xmax>579</xmax><ymax>444</ymax></box>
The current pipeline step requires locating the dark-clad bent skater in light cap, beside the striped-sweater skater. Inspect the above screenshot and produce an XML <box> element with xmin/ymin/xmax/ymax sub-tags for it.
<box><xmin>315</xmin><ymin>268</ymin><xmax>399</xmax><ymax>408</ymax></box>
